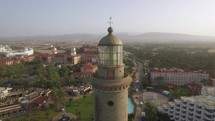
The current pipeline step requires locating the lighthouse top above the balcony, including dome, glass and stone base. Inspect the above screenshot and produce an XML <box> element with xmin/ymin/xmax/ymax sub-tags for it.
<box><xmin>98</xmin><ymin>27</ymin><xmax>124</xmax><ymax>79</ymax></box>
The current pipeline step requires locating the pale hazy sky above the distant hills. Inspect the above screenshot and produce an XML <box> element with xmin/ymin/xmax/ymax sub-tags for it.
<box><xmin>0</xmin><ymin>0</ymin><xmax>215</xmax><ymax>37</ymax></box>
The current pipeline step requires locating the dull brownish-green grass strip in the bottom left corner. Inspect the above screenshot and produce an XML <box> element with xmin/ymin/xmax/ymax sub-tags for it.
<box><xmin>4</xmin><ymin>109</ymin><xmax>58</xmax><ymax>121</ymax></box>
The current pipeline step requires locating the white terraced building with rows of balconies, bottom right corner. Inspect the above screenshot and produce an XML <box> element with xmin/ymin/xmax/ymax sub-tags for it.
<box><xmin>158</xmin><ymin>88</ymin><xmax>215</xmax><ymax>121</ymax></box>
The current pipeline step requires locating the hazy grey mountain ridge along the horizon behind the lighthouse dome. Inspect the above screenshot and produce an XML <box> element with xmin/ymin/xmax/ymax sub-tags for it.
<box><xmin>0</xmin><ymin>32</ymin><xmax>215</xmax><ymax>42</ymax></box>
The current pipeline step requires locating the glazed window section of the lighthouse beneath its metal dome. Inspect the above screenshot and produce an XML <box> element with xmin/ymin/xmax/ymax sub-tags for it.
<box><xmin>99</xmin><ymin>46</ymin><xmax>123</xmax><ymax>66</ymax></box>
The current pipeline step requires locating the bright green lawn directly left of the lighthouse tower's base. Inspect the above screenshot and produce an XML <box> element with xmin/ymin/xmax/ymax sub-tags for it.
<box><xmin>65</xmin><ymin>95</ymin><xmax>94</xmax><ymax>121</ymax></box>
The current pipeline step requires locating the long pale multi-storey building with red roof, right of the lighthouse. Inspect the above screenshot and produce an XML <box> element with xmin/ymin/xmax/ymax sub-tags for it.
<box><xmin>151</xmin><ymin>71</ymin><xmax>209</xmax><ymax>85</ymax></box>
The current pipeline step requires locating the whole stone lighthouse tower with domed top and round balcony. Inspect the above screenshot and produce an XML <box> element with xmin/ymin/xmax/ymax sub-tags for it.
<box><xmin>92</xmin><ymin>27</ymin><xmax>131</xmax><ymax>121</ymax></box>
